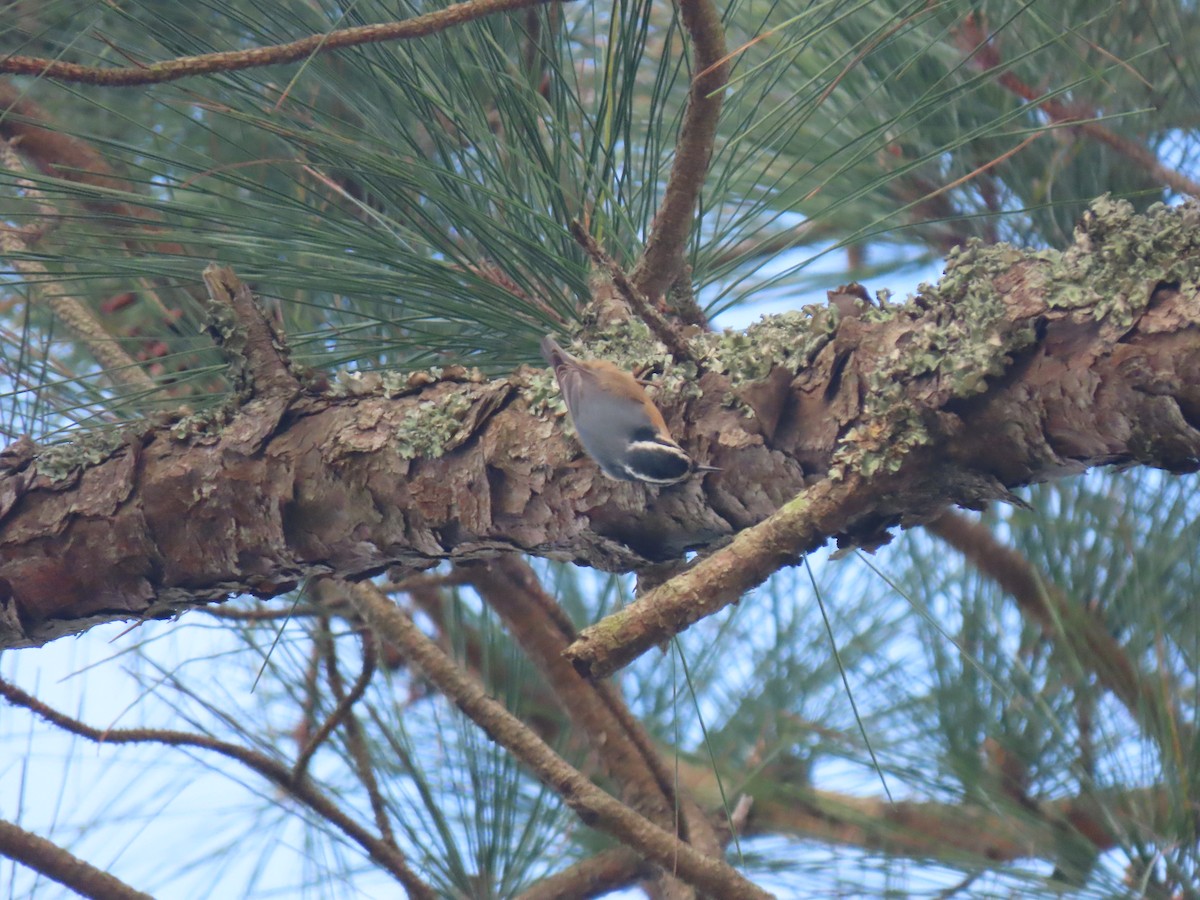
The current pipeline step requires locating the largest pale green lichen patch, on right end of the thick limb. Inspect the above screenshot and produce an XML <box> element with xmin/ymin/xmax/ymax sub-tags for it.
<box><xmin>830</xmin><ymin>197</ymin><xmax>1200</xmax><ymax>476</ymax></box>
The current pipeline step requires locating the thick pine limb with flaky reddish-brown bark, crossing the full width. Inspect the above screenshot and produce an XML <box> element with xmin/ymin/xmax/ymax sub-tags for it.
<box><xmin>0</xmin><ymin>200</ymin><xmax>1200</xmax><ymax>647</ymax></box>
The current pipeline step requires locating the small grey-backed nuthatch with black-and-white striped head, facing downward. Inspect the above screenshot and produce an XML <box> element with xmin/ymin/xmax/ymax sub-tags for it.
<box><xmin>541</xmin><ymin>335</ymin><xmax>720</xmax><ymax>485</ymax></box>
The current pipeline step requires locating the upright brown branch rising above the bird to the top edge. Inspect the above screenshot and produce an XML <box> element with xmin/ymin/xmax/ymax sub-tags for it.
<box><xmin>630</xmin><ymin>0</ymin><xmax>730</xmax><ymax>298</ymax></box>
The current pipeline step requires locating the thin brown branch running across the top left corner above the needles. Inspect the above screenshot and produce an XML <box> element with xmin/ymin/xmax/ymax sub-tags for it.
<box><xmin>0</xmin><ymin>0</ymin><xmax>576</xmax><ymax>88</ymax></box>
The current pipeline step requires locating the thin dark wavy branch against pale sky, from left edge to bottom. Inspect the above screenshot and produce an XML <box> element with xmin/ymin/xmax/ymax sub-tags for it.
<box><xmin>0</xmin><ymin>679</ymin><xmax>437</xmax><ymax>900</ymax></box>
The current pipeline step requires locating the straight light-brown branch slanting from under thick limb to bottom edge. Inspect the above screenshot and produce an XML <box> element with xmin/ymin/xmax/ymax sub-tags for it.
<box><xmin>353</xmin><ymin>582</ymin><xmax>770</xmax><ymax>900</ymax></box>
